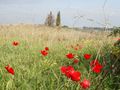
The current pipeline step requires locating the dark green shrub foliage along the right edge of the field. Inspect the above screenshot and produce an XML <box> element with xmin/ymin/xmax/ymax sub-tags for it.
<box><xmin>110</xmin><ymin>40</ymin><xmax>120</xmax><ymax>90</ymax></box>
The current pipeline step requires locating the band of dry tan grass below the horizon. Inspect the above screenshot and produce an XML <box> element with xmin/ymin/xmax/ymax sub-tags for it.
<box><xmin>0</xmin><ymin>24</ymin><xmax>111</xmax><ymax>45</ymax></box>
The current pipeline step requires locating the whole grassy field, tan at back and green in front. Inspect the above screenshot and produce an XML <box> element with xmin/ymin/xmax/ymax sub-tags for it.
<box><xmin>0</xmin><ymin>25</ymin><xmax>120</xmax><ymax>90</ymax></box>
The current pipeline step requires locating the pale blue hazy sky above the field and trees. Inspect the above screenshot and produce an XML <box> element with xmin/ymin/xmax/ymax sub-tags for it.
<box><xmin>0</xmin><ymin>0</ymin><xmax>120</xmax><ymax>27</ymax></box>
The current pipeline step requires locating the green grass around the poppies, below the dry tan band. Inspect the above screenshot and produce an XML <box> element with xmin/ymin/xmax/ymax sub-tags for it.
<box><xmin>0</xmin><ymin>29</ymin><xmax>120</xmax><ymax>90</ymax></box>
